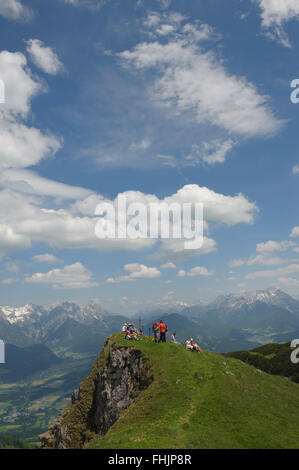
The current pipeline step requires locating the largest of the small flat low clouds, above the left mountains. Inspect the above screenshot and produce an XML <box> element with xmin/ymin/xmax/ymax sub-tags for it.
<box><xmin>25</xmin><ymin>262</ymin><xmax>99</xmax><ymax>289</ymax></box>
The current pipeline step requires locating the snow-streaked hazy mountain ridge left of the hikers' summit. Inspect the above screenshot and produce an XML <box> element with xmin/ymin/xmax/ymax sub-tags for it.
<box><xmin>0</xmin><ymin>302</ymin><xmax>124</xmax><ymax>352</ymax></box>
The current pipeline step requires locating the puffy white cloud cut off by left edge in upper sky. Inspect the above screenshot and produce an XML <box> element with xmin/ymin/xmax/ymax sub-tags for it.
<box><xmin>0</xmin><ymin>51</ymin><xmax>62</xmax><ymax>178</ymax></box>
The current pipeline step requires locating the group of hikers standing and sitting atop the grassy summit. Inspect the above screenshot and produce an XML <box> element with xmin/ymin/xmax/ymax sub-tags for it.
<box><xmin>122</xmin><ymin>320</ymin><xmax>202</xmax><ymax>352</ymax></box>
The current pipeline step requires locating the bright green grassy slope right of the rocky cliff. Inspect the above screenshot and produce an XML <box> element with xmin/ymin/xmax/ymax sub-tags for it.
<box><xmin>88</xmin><ymin>334</ymin><xmax>299</xmax><ymax>449</ymax></box>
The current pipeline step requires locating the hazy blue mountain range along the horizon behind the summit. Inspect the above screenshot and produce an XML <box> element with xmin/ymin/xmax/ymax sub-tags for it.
<box><xmin>0</xmin><ymin>288</ymin><xmax>299</xmax><ymax>353</ymax></box>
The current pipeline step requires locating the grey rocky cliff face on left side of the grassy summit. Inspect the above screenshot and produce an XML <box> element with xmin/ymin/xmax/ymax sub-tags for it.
<box><xmin>40</xmin><ymin>338</ymin><xmax>153</xmax><ymax>449</ymax></box>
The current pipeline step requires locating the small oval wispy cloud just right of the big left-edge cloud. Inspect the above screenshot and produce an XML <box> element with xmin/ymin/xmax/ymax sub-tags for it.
<box><xmin>26</xmin><ymin>39</ymin><xmax>63</xmax><ymax>75</ymax></box>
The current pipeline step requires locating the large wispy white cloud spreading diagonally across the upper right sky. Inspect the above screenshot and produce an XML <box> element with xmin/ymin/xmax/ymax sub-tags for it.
<box><xmin>118</xmin><ymin>20</ymin><xmax>283</xmax><ymax>138</ymax></box>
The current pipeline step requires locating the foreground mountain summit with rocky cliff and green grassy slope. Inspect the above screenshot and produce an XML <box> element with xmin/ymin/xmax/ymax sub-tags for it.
<box><xmin>41</xmin><ymin>333</ymin><xmax>299</xmax><ymax>449</ymax></box>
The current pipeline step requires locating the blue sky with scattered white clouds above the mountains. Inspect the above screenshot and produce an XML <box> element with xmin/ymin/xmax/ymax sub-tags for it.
<box><xmin>0</xmin><ymin>0</ymin><xmax>299</xmax><ymax>313</ymax></box>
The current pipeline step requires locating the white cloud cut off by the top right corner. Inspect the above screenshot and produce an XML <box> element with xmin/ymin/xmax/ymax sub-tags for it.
<box><xmin>252</xmin><ymin>0</ymin><xmax>299</xmax><ymax>47</ymax></box>
